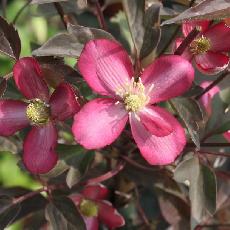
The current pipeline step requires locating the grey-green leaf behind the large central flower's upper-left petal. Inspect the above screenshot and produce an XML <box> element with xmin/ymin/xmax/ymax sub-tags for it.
<box><xmin>33</xmin><ymin>24</ymin><xmax>114</xmax><ymax>58</ymax></box>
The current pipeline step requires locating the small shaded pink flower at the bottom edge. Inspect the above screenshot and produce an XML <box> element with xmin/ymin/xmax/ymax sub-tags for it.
<box><xmin>70</xmin><ymin>184</ymin><xmax>125</xmax><ymax>230</ymax></box>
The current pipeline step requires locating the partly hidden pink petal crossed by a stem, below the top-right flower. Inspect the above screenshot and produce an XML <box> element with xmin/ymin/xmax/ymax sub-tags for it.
<box><xmin>200</xmin><ymin>81</ymin><xmax>220</xmax><ymax>116</ymax></box>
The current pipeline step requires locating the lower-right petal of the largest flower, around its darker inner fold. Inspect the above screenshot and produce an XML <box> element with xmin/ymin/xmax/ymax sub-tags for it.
<box><xmin>130</xmin><ymin>106</ymin><xmax>186</xmax><ymax>165</ymax></box>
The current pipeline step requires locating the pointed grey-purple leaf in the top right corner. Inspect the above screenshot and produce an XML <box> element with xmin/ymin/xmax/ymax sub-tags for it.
<box><xmin>162</xmin><ymin>0</ymin><xmax>230</xmax><ymax>25</ymax></box>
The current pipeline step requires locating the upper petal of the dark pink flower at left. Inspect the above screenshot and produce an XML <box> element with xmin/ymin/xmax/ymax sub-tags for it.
<box><xmin>13</xmin><ymin>57</ymin><xmax>49</xmax><ymax>101</ymax></box>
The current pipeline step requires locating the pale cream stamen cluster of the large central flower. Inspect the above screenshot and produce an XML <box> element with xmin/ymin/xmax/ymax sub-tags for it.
<box><xmin>117</xmin><ymin>78</ymin><xmax>149</xmax><ymax>112</ymax></box>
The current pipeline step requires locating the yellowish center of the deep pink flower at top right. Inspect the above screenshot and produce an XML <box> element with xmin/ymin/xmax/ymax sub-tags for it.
<box><xmin>190</xmin><ymin>36</ymin><xmax>211</xmax><ymax>55</ymax></box>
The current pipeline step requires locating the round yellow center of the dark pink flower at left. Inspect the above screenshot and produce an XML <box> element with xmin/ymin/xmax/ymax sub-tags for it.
<box><xmin>26</xmin><ymin>99</ymin><xmax>50</xmax><ymax>125</ymax></box>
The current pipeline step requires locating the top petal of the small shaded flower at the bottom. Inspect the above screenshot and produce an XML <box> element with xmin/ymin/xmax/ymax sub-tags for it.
<box><xmin>81</xmin><ymin>184</ymin><xmax>109</xmax><ymax>200</ymax></box>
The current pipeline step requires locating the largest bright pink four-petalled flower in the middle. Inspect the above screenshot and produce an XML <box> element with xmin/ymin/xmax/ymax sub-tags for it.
<box><xmin>72</xmin><ymin>39</ymin><xmax>194</xmax><ymax>165</ymax></box>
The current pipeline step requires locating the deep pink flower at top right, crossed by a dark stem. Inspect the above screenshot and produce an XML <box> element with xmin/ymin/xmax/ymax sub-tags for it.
<box><xmin>174</xmin><ymin>21</ymin><xmax>230</xmax><ymax>74</ymax></box>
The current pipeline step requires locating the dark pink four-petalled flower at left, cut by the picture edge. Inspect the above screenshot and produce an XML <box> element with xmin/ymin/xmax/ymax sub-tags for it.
<box><xmin>0</xmin><ymin>57</ymin><xmax>80</xmax><ymax>174</ymax></box>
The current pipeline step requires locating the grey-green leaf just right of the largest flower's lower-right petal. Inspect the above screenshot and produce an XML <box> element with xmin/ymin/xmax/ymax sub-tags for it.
<box><xmin>170</xmin><ymin>97</ymin><xmax>203</xmax><ymax>149</ymax></box>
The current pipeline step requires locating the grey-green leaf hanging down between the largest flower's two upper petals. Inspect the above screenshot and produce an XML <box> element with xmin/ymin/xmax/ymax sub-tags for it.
<box><xmin>123</xmin><ymin>0</ymin><xmax>161</xmax><ymax>59</ymax></box>
